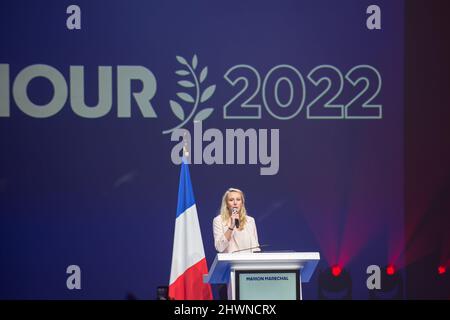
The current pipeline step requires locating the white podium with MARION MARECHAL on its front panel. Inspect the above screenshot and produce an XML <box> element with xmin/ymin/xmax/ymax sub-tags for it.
<box><xmin>203</xmin><ymin>252</ymin><xmax>320</xmax><ymax>300</ymax></box>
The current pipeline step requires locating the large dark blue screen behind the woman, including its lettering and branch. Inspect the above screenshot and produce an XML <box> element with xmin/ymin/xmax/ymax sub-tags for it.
<box><xmin>0</xmin><ymin>0</ymin><xmax>403</xmax><ymax>299</ymax></box>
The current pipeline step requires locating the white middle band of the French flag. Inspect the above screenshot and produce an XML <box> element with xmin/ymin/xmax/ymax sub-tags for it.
<box><xmin>170</xmin><ymin>204</ymin><xmax>205</xmax><ymax>284</ymax></box>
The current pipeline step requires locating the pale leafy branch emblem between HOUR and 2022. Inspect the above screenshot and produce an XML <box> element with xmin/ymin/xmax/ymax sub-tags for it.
<box><xmin>163</xmin><ymin>54</ymin><xmax>216</xmax><ymax>134</ymax></box>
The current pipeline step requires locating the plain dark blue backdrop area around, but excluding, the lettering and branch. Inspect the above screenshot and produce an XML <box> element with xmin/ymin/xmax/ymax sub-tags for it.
<box><xmin>0</xmin><ymin>0</ymin><xmax>403</xmax><ymax>299</ymax></box>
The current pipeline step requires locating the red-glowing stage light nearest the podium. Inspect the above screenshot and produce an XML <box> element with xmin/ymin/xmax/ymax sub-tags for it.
<box><xmin>319</xmin><ymin>265</ymin><xmax>352</xmax><ymax>300</ymax></box>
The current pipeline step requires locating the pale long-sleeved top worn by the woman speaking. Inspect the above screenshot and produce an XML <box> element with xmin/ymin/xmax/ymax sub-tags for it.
<box><xmin>213</xmin><ymin>215</ymin><xmax>261</xmax><ymax>253</ymax></box>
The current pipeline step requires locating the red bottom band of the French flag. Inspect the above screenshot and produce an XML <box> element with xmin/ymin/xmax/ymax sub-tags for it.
<box><xmin>169</xmin><ymin>258</ymin><xmax>212</xmax><ymax>300</ymax></box>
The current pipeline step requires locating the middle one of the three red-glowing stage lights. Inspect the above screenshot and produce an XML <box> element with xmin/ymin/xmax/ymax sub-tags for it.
<box><xmin>369</xmin><ymin>264</ymin><xmax>404</xmax><ymax>300</ymax></box>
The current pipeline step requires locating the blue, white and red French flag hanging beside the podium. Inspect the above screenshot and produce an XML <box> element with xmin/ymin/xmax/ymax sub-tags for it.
<box><xmin>169</xmin><ymin>159</ymin><xmax>212</xmax><ymax>300</ymax></box>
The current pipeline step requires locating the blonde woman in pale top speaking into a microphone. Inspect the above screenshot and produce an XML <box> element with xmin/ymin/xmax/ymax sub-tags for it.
<box><xmin>213</xmin><ymin>188</ymin><xmax>260</xmax><ymax>253</ymax></box>
